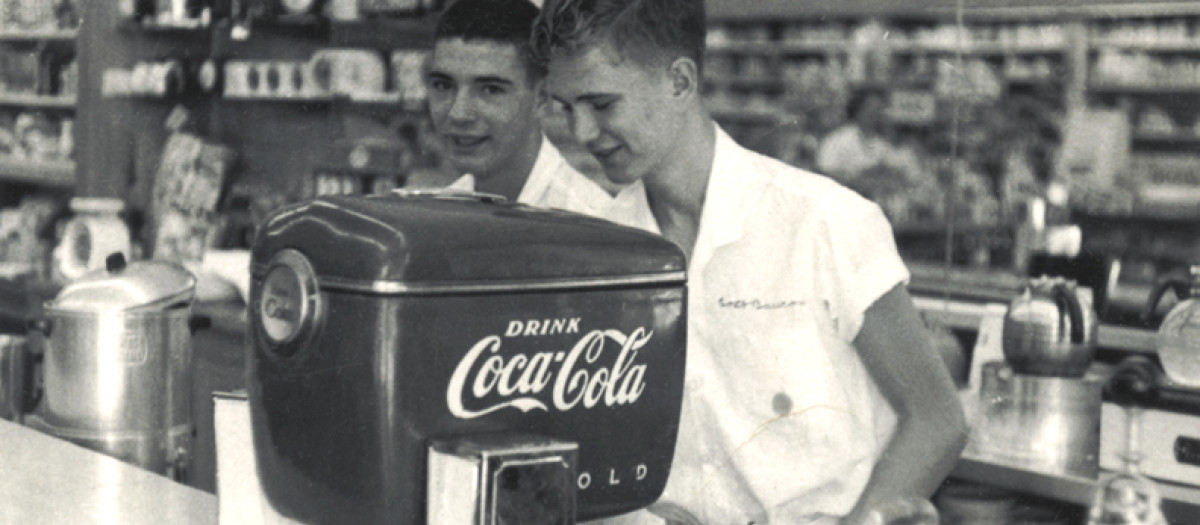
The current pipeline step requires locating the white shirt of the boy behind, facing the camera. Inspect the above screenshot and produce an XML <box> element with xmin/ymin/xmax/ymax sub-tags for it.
<box><xmin>446</xmin><ymin>135</ymin><xmax>658</xmax><ymax>233</ymax></box>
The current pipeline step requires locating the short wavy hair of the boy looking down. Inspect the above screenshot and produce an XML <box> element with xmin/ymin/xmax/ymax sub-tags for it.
<box><xmin>533</xmin><ymin>0</ymin><xmax>707</xmax><ymax>68</ymax></box>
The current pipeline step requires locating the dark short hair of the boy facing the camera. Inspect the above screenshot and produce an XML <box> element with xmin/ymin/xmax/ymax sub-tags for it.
<box><xmin>433</xmin><ymin>0</ymin><xmax>546</xmax><ymax>78</ymax></box>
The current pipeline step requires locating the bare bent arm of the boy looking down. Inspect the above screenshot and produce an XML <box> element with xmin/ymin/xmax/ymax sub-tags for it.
<box><xmin>842</xmin><ymin>285</ymin><xmax>967</xmax><ymax>525</ymax></box>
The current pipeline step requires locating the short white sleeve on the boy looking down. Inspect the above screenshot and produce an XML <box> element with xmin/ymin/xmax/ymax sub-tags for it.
<box><xmin>818</xmin><ymin>191</ymin><xmax>910</xmax><ymax>342</ymax></box>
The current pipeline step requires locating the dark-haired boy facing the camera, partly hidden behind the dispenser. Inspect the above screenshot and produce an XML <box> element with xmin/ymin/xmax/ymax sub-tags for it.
<box><xmin>426</xmin><ymin>0</ymin><xmax>653</xmax><ymax>228</ymax></box>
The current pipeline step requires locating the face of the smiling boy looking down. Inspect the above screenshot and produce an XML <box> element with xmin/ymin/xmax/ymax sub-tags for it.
<box><xmin>546</xmin><ymin>43</ymin><xmax>676</xmax><ymax>185</ymax></box>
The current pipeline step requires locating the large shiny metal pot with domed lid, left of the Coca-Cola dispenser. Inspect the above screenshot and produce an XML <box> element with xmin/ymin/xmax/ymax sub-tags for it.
<box><xmin>0</xmin><ymin>252</ymin><xmax>205</xmax><ymax>482</ymax></box>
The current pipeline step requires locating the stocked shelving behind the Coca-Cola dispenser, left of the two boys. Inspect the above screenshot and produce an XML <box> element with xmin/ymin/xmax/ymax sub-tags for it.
<box><xmin>76</xmin><ymin>2</ymin><xmax>446</xmax><ymax>251</ymax></box>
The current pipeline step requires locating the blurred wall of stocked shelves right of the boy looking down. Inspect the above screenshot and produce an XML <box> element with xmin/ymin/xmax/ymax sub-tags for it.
<box><xmin>706</xmin><ymin>1</ymin><xmax>1200</xmax><ymax>268</ymax></box>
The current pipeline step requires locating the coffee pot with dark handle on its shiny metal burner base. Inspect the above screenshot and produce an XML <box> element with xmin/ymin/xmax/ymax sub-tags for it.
<box><xmin>968</xmin><ymin>278</ymin><xmax>1104</xmax><ymax>477</ymax></box>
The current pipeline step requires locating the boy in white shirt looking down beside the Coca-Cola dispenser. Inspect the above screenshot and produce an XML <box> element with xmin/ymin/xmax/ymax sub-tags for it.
<box><xmin>534</xmin><ymin>0</ymin><xmax>966</xmax><ymax>525</ymax></box>
